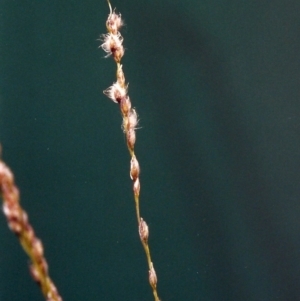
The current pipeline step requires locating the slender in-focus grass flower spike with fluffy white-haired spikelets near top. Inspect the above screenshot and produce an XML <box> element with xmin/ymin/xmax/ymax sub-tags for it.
<box><xmin>101</xmin><ymin>0</ymin><xmax>159</xmax><ymax>301</ymax></box>
